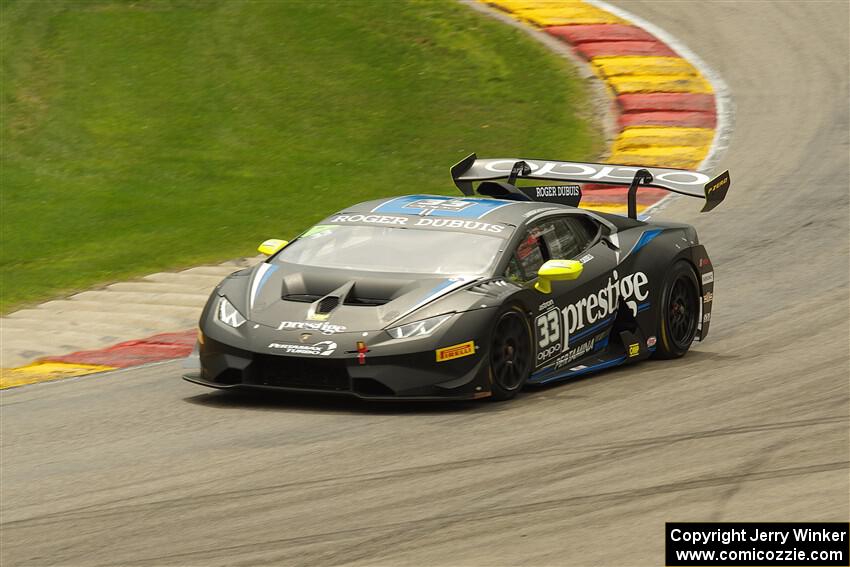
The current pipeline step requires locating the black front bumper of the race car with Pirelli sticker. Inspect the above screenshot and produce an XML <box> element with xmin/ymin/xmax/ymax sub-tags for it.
<box><xmin>184</xmin><ymin>336</ymin><xmax>490</xmax><ymax>400</ymax></box>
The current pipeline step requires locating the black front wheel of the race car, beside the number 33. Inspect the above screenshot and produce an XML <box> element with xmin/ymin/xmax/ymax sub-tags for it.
<box><xmin>490</xmin><ymin>305</ymin><xmax>534</xmax><ymax>402</ymax></box>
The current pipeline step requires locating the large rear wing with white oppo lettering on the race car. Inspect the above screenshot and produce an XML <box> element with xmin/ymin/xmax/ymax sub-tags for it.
<box><xmin>451</xmin><ymin>154</ymin><xmax>730</xmax><ymax>218</ymax></box>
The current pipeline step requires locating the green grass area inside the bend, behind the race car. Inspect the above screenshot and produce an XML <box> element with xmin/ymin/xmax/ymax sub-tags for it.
<box><xmin>0</xmin><ymin>0</ymin><xmax>602</xmax><ymax>312</ymax></box>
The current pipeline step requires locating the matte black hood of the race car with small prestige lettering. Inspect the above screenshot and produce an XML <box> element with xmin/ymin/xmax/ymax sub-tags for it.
<box><xmin>238</xmin><ymin>262</ymin><xmax>481</xmax><ymax>334</ymax></box>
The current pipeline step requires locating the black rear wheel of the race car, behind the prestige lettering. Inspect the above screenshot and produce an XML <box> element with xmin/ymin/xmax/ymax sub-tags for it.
<box><xmin>653</xmin><ymin>260</ymin><xmax>701</xmax><ymax>359</ymax></box>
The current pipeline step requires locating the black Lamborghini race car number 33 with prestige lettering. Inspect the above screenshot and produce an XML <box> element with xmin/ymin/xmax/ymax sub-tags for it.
<box><xmin>185</xmin><ymin>154</ymin><xmax>730</xmax><ymax>400</ymax></box>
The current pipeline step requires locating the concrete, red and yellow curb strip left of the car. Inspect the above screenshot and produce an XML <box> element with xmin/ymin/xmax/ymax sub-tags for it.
<box><xmin>0</xmin><ymin>257</ymin><xmax>258</xmax><ymax>389</ymax></box>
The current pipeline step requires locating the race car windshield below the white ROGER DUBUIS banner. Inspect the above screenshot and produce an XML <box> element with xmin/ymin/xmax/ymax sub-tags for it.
<box><xmin>275</xmin><ymin>224</ymin><xmax>507</xmax><ymax>275</ymax></box>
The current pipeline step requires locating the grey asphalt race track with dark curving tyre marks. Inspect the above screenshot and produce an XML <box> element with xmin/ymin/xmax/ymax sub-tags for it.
<box><xmin>0</xmin><ymin>2</ymin><xmax>850</xmax><ymax>566</ymax></box>
